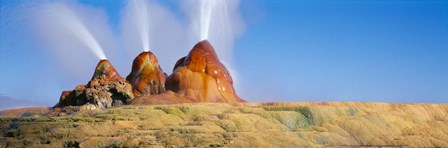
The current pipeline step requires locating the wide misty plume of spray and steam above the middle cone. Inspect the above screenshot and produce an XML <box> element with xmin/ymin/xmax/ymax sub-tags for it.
<box><xmin>120</xmin><ymin>0</ymin><xmax>186</xmax><ymax>70</ymax></box>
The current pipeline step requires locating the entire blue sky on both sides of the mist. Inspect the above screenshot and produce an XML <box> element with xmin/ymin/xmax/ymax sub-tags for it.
<box><xmin>0</xmin><ymin>0</ymin><xmax>448</xmax><ymax>106</ymax></box>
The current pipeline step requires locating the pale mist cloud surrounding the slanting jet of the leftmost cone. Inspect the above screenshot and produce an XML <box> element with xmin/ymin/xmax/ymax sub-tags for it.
<box><xmin>30</xmin><ymin>1</ymin><xmax>119</xmax><ymax>81</ymax></box>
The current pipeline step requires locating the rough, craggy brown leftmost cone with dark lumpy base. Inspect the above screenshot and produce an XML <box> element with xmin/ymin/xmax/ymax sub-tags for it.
<box><xmin>55</xmin><ymin>60</ymin><xmax>134</xmax><ymax>110</ymax></box>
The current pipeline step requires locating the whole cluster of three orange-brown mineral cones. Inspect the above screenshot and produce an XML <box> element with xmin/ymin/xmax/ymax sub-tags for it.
<box><xmin>55</xmin><ymin>40</ymin><xmax>246</xmax><ymax>110</ymax></box>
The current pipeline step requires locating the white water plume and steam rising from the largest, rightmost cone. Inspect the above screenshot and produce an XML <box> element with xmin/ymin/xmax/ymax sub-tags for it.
<box><xmin>181</xmin><ymin>0</ymin><xmax>245</xmax><ymax>89</ymax></box>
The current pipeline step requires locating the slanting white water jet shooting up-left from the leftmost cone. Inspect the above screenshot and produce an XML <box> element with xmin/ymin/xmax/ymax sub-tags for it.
<box><xmin>42</xmin><ymin>3</ymin><xmax>107</xmax><ymax>59</ymax></box>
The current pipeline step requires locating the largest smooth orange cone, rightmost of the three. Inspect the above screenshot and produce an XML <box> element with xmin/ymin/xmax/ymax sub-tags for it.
<box><xmin>165</xmin><ymin>40</ymin><xmax>245</xmax><ymax>102</ymax></box>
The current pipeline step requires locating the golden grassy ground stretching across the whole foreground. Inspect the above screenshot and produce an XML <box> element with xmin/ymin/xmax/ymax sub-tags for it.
<box><xmin>0</xmin><ymin>102</ymin><xmax>448</xmax><ymax>147</ymax></box>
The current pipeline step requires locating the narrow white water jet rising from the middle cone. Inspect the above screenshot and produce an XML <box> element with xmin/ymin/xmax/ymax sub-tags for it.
<box><xmin>126</xmin><ymin>0</ymin><xmax>150</xmax><ymax>51</ymax></box>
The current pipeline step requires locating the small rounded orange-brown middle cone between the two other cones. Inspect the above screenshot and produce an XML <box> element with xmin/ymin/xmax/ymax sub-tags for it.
<box><xmin>126</xmin><ymin>51</ymin><xmax>166</xmax><ymax>97</ymax></box>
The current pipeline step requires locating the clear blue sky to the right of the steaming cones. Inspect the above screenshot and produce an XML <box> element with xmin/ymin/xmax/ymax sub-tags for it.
<box><xmin>236</xmin><ymin>1</ymin><xmax>448</xmax><ymax>103</ymax></box>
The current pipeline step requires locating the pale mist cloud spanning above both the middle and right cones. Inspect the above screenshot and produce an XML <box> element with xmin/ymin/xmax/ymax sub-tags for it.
<box><xmin>120</xmin><ymin>0</ymin><xmax>245</xmax><ymax>74</ymax></box>
